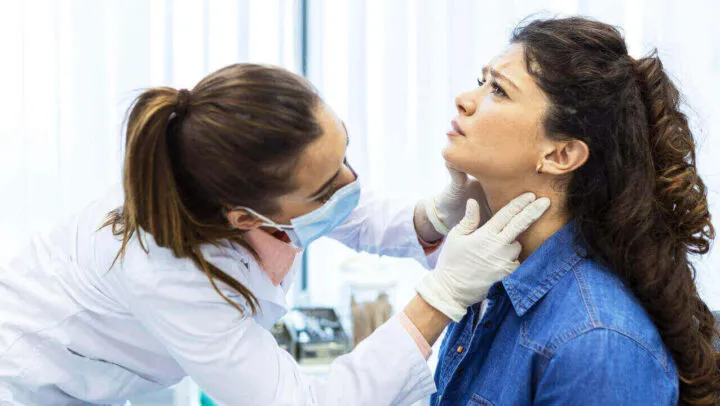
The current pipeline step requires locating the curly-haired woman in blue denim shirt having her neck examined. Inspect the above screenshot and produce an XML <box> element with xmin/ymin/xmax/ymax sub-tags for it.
<box><xmin>433</xmin><ymin>18</ymin><xmax>720</xmax><ymax>405</ymax></box>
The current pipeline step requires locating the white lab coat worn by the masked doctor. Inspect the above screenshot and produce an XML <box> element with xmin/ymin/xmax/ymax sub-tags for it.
<box><xmin>0</xmin><ymin>188</ymin><xmax>435</xmax><ymax>406</ymax></box>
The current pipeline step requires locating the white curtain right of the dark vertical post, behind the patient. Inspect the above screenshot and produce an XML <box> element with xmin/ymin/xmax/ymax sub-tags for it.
<box><xmin>308</xmin><ymin>0</ymin><xmax>720</xmax><ymax>311</ymax></box>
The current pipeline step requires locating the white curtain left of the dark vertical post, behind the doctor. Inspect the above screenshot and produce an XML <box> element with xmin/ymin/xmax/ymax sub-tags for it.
<box><xmin>0</xmin><ymin>0</ymin><xmax>300</xmax><ymax>260</ymax></box>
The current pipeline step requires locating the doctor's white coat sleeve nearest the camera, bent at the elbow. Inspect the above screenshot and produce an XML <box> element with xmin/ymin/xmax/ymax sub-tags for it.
<box><xmin>121</xmin><ymin>269</ymin><xmax>435</xmax><ymax>406</ymax></box>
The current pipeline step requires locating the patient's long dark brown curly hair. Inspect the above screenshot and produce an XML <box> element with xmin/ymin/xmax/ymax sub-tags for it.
<box><xmin>512</xmin><ymin>18</ymin><xmax>720</xmax><ymax>405</ymax></box>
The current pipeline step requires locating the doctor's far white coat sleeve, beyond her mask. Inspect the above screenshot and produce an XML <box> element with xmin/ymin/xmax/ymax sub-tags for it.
<box><xmin>328</xmin><ymin>190</ymin><xmax>440</xmax><ymax>269</ymax></box>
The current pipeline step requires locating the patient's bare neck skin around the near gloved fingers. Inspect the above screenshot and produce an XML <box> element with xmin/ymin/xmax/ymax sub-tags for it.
<box><xmin>485</xmin><ymin>187</ymin><xmax>570</xmax><ymax>262</ymax></box>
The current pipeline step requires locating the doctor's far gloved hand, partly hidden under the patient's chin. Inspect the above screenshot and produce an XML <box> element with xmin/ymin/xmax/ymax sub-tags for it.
<box><xmin>424</xmin><ymin>164</ymin><xmax>485</xmax><ymax>235</ymax></box>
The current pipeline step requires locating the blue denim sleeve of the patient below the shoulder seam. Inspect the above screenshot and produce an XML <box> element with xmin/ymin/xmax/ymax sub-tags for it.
<box><xmin>533</xmin><ymin>329</ymin><xmax>678</xmax><ymax>405</ymax></box>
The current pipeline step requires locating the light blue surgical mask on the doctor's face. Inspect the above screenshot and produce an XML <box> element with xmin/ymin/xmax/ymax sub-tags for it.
<box><xmin>235</xmin><ymin>180</ymin><xmax>360</xmax><ymax>249</ymax></box>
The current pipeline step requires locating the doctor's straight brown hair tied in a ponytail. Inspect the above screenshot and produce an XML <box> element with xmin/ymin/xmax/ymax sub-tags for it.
<box><xmin>104</xmin><ymin>64</ymin><xmax>322</xmax><ymax>314</ymax></box>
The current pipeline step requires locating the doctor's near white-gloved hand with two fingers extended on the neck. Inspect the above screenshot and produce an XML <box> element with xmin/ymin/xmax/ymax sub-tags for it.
<box><xmin>416</xmin><ymin>193</ymin><xmax>550</xmax><ymax>322</ymax></box>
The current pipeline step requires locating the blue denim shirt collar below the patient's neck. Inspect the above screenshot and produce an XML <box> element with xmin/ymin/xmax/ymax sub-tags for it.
<box><xmin>502</xmin><ymin>221</ymin><xmax>586</xmax><ymax>317</ymax></box>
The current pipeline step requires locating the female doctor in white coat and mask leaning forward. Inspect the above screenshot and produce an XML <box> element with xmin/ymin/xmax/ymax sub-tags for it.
<box><xmin>0</xmin><ymin>65</ymin><xmax>548</xmax><ymax>406</ymax></box>
